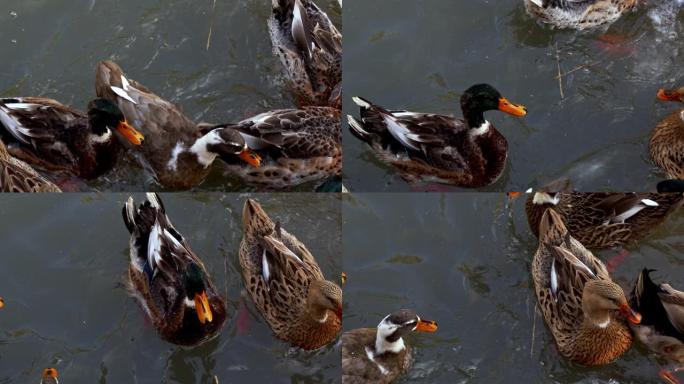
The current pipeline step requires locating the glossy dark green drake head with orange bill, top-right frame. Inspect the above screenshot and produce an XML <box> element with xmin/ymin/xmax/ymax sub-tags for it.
<box><xmin>461</xmin><ymin>84</ymin><xmax>527</xmax><ymax>133</ymax></box>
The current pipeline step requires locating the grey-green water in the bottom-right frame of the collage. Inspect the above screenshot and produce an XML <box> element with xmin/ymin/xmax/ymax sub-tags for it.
<box><xmin>343</xmin><ymin>193</ymin><xmax>684</xmax><ymax>384</ymax></box>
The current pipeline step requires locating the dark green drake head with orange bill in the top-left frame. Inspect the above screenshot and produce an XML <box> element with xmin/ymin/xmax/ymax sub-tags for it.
<box><xmin>88</xmin><ymin>98</ymin><xmax>144</xmax><ymax>145</ymax></box>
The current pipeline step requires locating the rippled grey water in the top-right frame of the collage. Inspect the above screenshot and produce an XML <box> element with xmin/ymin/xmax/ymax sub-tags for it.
<box><xmin>343</xmin><ymin>0</ymin><xmax>684</xmax><ymax>192</ymax></box>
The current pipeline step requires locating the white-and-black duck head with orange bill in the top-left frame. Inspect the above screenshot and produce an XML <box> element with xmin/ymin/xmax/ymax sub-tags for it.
<box><xmin>190</xmin><ymin>128</ymin><xmax>261</xmax><ymax>168</ymax></box>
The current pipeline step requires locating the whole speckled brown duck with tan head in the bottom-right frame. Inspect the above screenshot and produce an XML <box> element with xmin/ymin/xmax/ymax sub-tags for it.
<box><xmin>532</xmin><ymin>208</ymin><xmax>641</xmax><ymax>366</ymax></box>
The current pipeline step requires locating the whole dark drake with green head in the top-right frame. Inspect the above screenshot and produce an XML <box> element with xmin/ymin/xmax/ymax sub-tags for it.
<box><xmin>347</xmin><ymin>84</ymin><xmax>527</xmax><ymax>188</ymax></box>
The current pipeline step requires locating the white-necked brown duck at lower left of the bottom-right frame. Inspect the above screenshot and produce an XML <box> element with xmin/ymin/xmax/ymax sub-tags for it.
<box><xmin>342</xmin><ymin>309</ymin><xmax>437</xmax><ymax>384</ymax></box>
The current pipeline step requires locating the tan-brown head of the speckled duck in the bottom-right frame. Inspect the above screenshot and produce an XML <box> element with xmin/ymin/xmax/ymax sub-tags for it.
<box><xmin>582</xmin><ymin>280</ymin><xmax>641</xmax><ymax>328</ymax></box>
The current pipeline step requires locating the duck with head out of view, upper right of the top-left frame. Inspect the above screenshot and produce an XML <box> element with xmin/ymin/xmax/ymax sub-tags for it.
<box><xmin>268</xmin><ymin>0</ymin><xmax>342</xmax><ymax>109</ymax></box>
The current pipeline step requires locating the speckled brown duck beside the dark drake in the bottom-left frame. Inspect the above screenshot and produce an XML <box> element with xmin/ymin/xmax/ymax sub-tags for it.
<box><xmin>239</xmin><ymin>199</ymin><xmax>342</xmax><ymax>350</ymax></box>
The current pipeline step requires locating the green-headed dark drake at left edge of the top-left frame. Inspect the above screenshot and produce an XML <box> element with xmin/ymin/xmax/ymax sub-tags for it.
<box><xmin>0</xmin><ymin>97</ymin><xmax>143</xmax><ymax>179</ymax></box>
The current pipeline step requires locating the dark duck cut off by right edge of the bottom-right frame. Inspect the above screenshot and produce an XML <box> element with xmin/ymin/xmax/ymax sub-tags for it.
<box><xmin>631</xmin><ymin>268</ymin><xmax>684</xmax><ymax>363</ymax></box>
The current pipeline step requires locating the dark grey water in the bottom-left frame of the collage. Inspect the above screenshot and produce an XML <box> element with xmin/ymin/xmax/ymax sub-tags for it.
<box><xmin>0</xmin><ymin>193</ymin><xmax>341</xmax><ymax>384</ymax></box>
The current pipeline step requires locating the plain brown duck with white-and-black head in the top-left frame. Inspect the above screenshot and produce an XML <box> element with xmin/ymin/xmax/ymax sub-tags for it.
<box><xmin>95</xmin><ymin>60</ymin><xmax>261</xmax><ymax>190</ymax></box>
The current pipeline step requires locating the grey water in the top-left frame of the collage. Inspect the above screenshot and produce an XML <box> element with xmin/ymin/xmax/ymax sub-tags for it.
<box><xmin>0</xmin><ymin>0</ymin><xmax>341</xmax><ymax>191</ymax></box>
